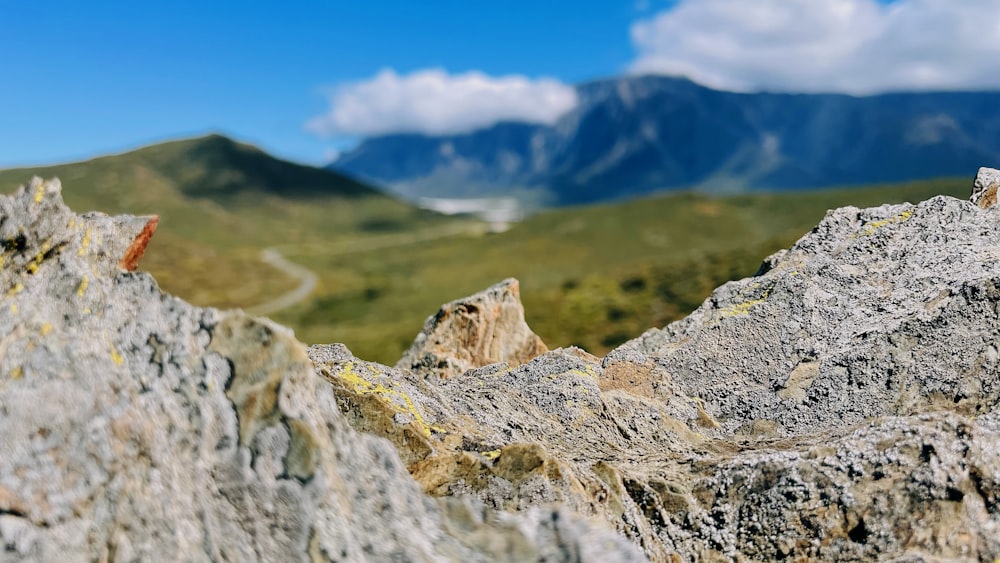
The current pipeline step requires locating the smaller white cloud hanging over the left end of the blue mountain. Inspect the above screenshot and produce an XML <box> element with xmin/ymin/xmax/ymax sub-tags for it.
<box><xmin>306</xmin><ymin>69</ymin><xmax>577</xmax><ymax>136</ymax></box>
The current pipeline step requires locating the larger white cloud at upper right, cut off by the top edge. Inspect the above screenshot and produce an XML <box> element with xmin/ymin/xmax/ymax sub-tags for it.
<box><xmin>630</xmin><ymin>0</ymin><xmax>1000</xmax><ymax>94</ymax></box>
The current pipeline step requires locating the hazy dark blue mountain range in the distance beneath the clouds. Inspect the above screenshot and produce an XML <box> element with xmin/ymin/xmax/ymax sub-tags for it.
<box><xmin>330</xmin><ymin>76</ymin><xmax>1000</xmax><ymax>205</ymax></box>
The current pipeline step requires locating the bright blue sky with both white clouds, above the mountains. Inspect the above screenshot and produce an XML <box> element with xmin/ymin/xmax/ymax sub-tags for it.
<box><xmin>0</xmin><ymin>0</ymin><xmax>1000</xmax><ymax>167</ymax></box>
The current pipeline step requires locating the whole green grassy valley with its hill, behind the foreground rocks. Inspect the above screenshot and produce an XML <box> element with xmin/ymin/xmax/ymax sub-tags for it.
<box><xmin>0</xmin><ymin>136</ymin><xmax>971</xmax><ymax>364</ymax></box>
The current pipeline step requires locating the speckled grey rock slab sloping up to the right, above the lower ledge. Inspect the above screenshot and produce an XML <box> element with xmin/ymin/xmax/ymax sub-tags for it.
<box><xmin>624</xmin><ymin>197</ymin><xmax>1000</xmax><ymax>437</ymax></box>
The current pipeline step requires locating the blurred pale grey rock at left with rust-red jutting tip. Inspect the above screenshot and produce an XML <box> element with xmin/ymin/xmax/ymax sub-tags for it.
<box><xmin>0</xmin><ymin>179</ymin><xmax>641</xmax><ymax>561</ymax></box>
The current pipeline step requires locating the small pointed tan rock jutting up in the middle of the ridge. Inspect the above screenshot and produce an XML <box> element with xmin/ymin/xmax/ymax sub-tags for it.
<box><xmin>396</xmin><ymin>279</ymin><xmax>548</xmax><ymax>377</ymax></box>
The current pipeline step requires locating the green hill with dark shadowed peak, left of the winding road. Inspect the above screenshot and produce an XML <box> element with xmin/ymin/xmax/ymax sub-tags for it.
<box><xmin>0</xmin><ymin>135</ymin><xmax>454</xmax><ymax>307</ymax></box>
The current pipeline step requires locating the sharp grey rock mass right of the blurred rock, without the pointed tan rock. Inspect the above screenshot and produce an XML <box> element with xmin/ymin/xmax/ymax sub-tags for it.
<box><xmin>309</xmin><ymin>170</ymin><xmax>1000</xmax><ymax>561</ymax></box>
